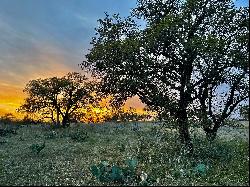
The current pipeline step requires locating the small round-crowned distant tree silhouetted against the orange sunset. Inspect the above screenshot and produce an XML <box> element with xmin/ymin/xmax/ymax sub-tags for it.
<box><xmin>18</xmin><ymin>72</ymin><xmax>94</xmax><ymax>127</ymax></box>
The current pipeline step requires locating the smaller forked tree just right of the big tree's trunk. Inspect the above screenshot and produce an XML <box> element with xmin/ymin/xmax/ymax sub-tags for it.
<box><xmin>198</xmin><ymin>73</ymin><xmax>249</xmax><ymax>140</ymax></box>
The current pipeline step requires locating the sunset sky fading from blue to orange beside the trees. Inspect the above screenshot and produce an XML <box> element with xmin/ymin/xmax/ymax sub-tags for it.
<box><xmin>0</xmin><ymin>0</ymin><xmax>249</xmax><ymax>115</ymax></box>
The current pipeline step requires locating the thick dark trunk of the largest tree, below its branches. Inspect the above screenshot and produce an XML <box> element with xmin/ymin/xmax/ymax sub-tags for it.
<box><xmin>177</xmin><ymin>109</ymin><xmax>193</xmax><ymax>154</ymax></box>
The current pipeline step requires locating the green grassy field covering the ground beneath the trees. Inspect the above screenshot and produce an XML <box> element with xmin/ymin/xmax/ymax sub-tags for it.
<box><xmin>0</xmin><ymin>122</ymin><xmax>249</xmax><ymax>186</ymax></box>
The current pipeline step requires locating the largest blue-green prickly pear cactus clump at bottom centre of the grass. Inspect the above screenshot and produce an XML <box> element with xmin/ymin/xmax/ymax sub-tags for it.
<box><xmin>90</xmin><ymin>159</ymin><xmax>138</xmax><ymax>184</ymax></box>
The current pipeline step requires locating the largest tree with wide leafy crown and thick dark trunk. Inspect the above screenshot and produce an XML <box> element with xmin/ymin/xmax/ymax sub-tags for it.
<box><xmin>82</xmin><ymin>0</ymin><xmax>249</xmax><ymax>151</ymax></box>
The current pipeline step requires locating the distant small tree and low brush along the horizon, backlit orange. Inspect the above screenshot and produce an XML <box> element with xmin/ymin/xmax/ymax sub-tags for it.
<box><xmin>15</xmin><ymin>72</ymin><xmax>153</xmax><ymax>127</ymax></box>
